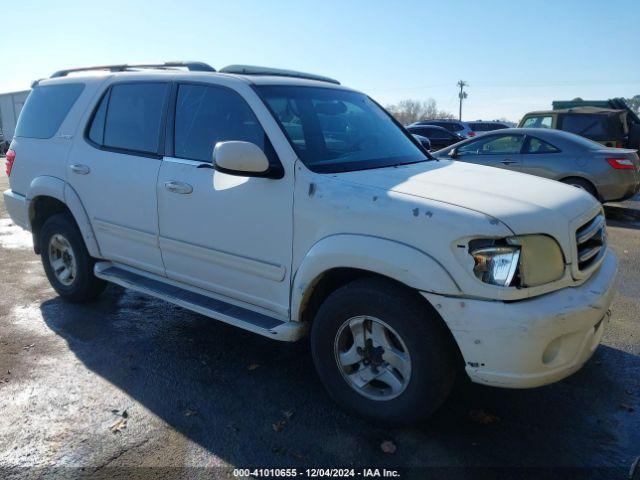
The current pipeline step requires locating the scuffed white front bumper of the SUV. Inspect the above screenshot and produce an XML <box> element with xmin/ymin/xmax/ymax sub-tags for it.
<box><xmin>422</xmin><ymin>249</ymin><xmax>618</xmax><ymax>388</ymax></box>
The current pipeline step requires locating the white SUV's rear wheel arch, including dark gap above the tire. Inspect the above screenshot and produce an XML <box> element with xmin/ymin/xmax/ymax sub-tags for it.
<box><xmin>27</xmin><ymin>176</ymin><xmax>101</xmax><ymax>258</ymax></box>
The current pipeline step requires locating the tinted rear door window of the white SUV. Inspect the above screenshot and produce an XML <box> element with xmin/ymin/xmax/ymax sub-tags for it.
<box><xmin>100</xmin><ymin>83</ymin><xmax>168</xmax><ymax>153</ymax></box>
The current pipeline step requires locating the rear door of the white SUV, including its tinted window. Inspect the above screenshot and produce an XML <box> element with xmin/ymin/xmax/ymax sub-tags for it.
<box><xmin>67</xmin><ymin>82</ymin><xmax>169</xmax><ymax>275</ymax></box>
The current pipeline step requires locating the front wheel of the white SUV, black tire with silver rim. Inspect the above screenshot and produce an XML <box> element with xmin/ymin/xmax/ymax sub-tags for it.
<box><xmin>311</xmin><ymin>278</ymin><xmax>457</xmax><ymax>426</ymax></box>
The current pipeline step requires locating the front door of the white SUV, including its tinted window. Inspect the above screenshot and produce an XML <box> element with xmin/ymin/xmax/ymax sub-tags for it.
<box><xmin>158</xmin><ymin>84</ymin><xmax>293</xmax><ymax>318</ymax></box>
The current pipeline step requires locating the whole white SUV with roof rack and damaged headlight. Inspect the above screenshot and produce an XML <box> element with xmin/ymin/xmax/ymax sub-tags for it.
<box><xmin>4</xmin><ymin>63</ymin><xmax>617</xmax><ymax>424</ymax></box>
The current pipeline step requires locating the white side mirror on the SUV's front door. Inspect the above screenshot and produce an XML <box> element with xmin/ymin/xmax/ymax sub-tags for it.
<box><xmin>213</xmin><ymin>141</ymin><xmax>282</xmax><ymax>178</ymax></box>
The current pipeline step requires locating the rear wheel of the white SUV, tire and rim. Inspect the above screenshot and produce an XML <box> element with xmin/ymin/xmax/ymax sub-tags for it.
<box><xmin>38</xmin><ymin>213</ymin><xmax>106</xmax><ymax>303</ymax></box>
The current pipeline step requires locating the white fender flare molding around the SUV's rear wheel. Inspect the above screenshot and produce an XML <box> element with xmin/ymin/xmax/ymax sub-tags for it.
<box><xmin>27</xmin><ymin>175</ymin><xmax>102</xmax><ymax>258</ymax></box>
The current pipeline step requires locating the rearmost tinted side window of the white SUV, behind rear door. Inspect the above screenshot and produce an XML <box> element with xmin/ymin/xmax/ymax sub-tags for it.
<box><xmin>15</xmin><ymin>83</ymin><xmax>84</xmax><ymax>138</ymax></box>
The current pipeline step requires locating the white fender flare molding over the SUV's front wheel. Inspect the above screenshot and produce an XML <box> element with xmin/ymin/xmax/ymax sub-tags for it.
<box><xmin>291</xmin><ymin>234</ymin><xmax>461</xmax><ymax>321</ymax></box>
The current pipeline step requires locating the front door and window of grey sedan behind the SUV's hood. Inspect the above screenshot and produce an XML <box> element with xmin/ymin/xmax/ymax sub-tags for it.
<box><xmin>456</xmin><ymin>133</ymin><xmax>524</xmax><ymax>171</ymax></box>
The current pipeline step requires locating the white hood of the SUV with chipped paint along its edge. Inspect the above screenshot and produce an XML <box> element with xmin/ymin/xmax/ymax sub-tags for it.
<box><xmin>337</xmin><ymin>160</ymin><xmax>601</xmax><ymax>238</ymax></box>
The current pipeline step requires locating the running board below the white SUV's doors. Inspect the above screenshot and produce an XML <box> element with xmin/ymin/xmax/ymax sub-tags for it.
<box><xmin>94</xmin><ymin>262</ymin><xmax>306</xmax><ymax>342</ymax></box>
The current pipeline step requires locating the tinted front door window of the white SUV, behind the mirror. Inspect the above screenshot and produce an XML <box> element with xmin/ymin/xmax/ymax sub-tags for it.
<box><xmin>175</xmin><ymin>85</ymin><xmax>271</xmax><ymax>162</ymax></box>
